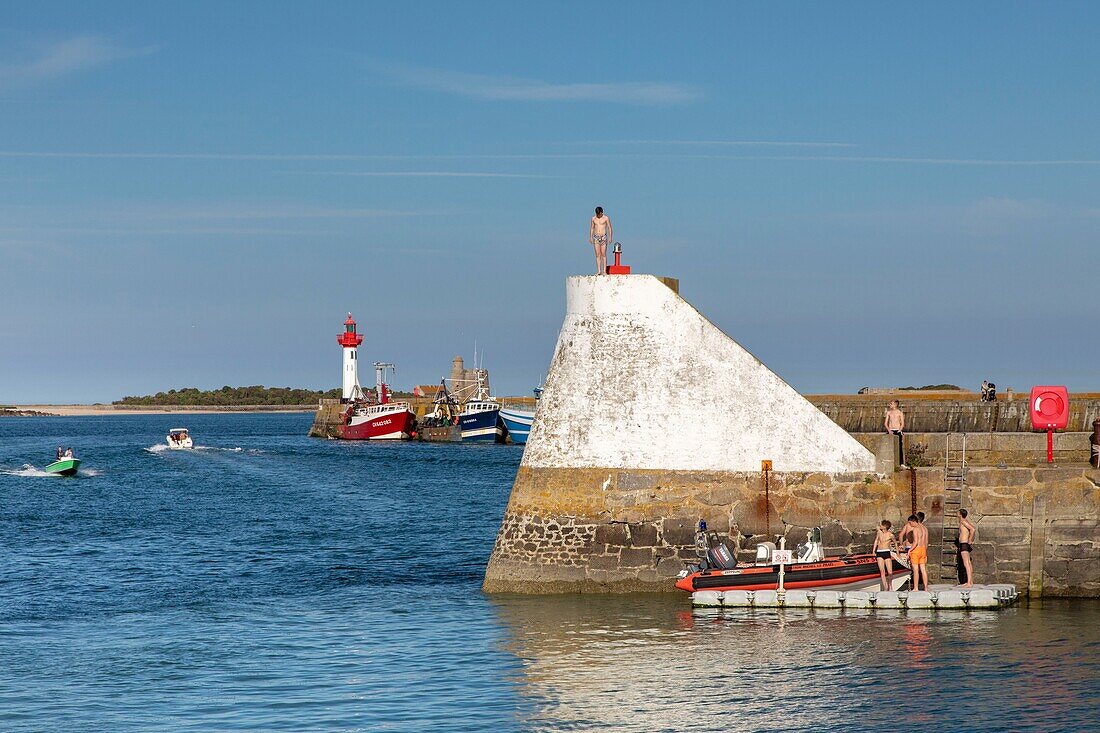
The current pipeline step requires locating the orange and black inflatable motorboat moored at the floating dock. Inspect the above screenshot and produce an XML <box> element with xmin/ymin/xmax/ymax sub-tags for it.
<box><xmin>677</xmin><ymin>527</ymin><xmax>910</xmax><ymax>593</ymax></box>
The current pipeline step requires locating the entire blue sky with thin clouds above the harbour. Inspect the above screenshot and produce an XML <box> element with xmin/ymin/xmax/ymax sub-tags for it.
<box><xmin>0</xmin><ymin>2</ymin><xmax>1100</xmax><ymax>402</ymax></box>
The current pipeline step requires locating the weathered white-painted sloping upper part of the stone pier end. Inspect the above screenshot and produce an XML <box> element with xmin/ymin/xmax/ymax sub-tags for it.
<box><xmin>523</xmin><ymin>270</ymin><xmax>876</xmax><ymax>473</ymax></box>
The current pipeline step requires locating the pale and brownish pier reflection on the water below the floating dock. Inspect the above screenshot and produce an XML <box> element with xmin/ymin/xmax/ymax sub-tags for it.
<box><xmin>491</xmin><ymin>595</ymin><xmax>1100</xmax><ymax>732</ymax></box>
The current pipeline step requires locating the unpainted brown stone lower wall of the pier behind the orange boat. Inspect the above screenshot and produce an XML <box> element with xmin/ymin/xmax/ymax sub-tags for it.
<box><xmin>484</xmin><ymin>467</ymin><xmax>1100</xmax><ymax>597</ymax></box>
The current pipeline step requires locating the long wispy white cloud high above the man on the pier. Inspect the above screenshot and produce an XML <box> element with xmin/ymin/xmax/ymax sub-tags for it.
<box><xmin>371</xmin><ymin>64</ymin><xmax>703</xmax><ymax>106</ymax></box>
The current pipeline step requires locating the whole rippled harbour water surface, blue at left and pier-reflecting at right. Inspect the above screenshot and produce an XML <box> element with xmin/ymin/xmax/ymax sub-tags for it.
<box><xmin>0</xmin><ymin>415</ymin><xmax>1100</xmax><ymax>733</ymax></box>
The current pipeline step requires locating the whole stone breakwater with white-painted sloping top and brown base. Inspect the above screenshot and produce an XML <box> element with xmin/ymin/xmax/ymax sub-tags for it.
<box><xmin>483</xmin><ymin>275</ymin><xmax>1100</xmax><ymax>597</ymax></box>
